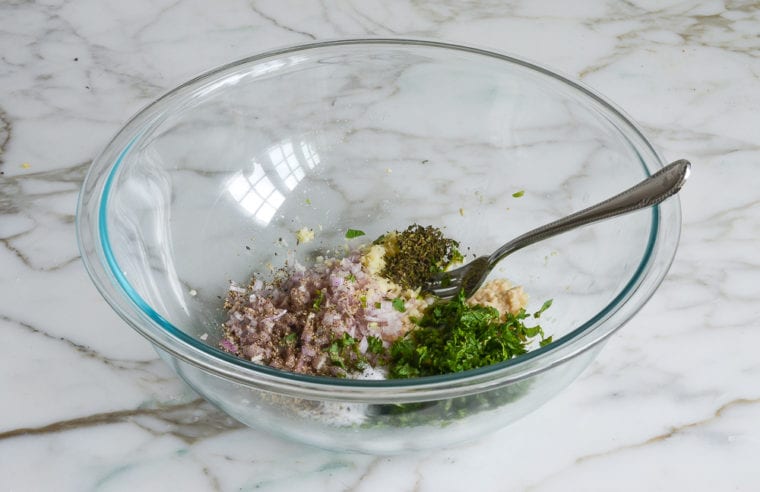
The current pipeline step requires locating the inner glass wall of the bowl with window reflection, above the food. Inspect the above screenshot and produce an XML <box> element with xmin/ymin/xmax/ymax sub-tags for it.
<box><xmin>105</xmin><ymin>45</ymin><xmax>649</xmax><ymax>342</ymax></box>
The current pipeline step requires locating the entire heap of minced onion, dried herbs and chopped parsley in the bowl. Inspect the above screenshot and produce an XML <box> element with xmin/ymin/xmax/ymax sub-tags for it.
<box><xmin>220</xmin><ymin>224</ymin><xmax>551</xmax><ymax>379</ymax></box>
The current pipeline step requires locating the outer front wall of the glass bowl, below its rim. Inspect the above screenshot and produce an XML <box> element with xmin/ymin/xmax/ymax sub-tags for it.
<box><xmin>159</xmin><ymin>346</ymin><xmax>601</xmax><ymax>455</ymax></box>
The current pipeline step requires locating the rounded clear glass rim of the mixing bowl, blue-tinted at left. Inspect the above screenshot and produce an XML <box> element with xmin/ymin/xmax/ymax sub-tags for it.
<box><xmin>76</xmin><ymin>38</ymin><xmax>681</xmax><ymax>402</ymax></box>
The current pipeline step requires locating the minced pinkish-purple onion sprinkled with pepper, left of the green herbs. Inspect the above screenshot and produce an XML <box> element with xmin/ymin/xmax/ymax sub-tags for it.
<box><xmin>221</xmin><ymin>251</ymin><xmax>424</xmax><ymax>374</ymax></box>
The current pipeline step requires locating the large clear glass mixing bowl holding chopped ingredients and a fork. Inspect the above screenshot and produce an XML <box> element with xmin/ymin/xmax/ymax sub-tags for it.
<box><xmin>77</xmin><ymin>39</ymin><xmax>680</xmax><ymax>453</ymax></box>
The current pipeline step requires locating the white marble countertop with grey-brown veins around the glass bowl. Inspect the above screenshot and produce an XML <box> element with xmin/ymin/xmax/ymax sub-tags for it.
<box><xmin>0</xmin><ymin>0</ymin><xmax>760</xmax><ymax>491</ymax></box>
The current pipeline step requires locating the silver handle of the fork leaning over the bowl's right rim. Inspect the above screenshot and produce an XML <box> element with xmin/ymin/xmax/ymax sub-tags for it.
<box><xmin>488</xmin><ymin>159</ymin><xmax>691</xmax><ymax>266</ymax></box>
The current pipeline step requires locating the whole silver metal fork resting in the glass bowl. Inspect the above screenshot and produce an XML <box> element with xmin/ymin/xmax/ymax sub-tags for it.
<box><xmin>422</xmin><ymin>159</ymin><xmax>691</xmax><ymax>300</ymax></box>
